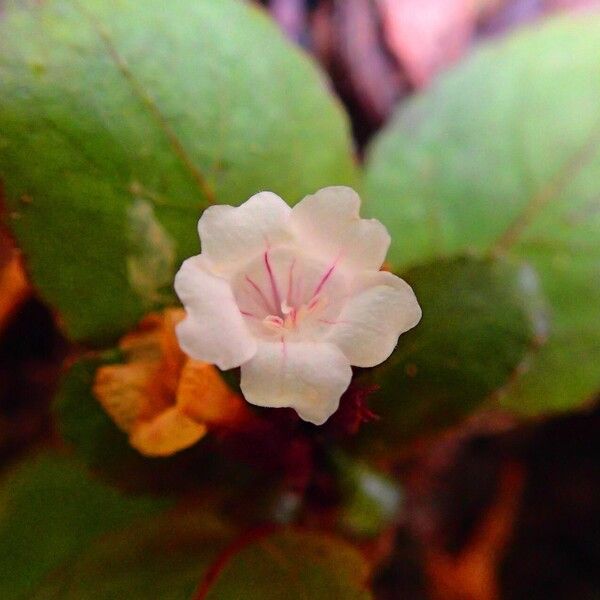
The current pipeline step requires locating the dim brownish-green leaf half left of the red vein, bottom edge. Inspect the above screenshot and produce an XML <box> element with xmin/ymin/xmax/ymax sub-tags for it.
<box><xmin>33</xmin><ymin>508</ymin><xmax>234</xmax><ymax>600</ymax></box>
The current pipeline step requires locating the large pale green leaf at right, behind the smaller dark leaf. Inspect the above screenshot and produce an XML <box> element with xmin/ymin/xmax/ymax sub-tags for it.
<box><xmin>367</xmin><ymin>15</ymin><xmax>600</xmax><ymax>413</ymax></box>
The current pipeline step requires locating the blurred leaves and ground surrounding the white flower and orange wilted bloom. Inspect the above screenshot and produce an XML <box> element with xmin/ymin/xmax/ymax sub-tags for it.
<box><xmin>0</xmin><ymin>0</ymin><xmax>600</xmax><ymax>600</ymax></box>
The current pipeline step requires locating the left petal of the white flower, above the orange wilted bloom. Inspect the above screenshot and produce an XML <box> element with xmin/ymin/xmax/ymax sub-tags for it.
<box><xmin>175</xmin><ymin>256</ymin><xmax>256</xmax><ymax>370</ymax></box>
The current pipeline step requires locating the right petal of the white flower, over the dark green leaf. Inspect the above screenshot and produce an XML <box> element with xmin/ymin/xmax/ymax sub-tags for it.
<box><xmin>326</xmin><ymin>271</ymin><xmax>421</xmax><ymax>367</ymax></box>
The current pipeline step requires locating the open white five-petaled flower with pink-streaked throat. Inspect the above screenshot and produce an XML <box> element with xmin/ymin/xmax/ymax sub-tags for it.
<box><xmin>175</xmin><ymin>187</ymin><xmax>421</xmax><ymax>425</ymax></box>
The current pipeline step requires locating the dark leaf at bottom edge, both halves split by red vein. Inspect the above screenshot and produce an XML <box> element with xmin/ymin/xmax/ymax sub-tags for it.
<box><xmin>25</xmin><ymin>509</ymin><xmax>371</xmax><ymax>600</ymax></box>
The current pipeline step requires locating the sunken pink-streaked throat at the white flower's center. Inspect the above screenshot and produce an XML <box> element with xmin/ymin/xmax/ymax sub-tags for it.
<box><xmin>233</xmin><ymin>248</ymin><xmax>346</xmax><ymax>340</ymax></box>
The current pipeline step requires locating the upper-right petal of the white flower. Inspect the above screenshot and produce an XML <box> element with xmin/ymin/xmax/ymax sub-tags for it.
<box><xmin>290</xmin><ymin>187</ymin><xmax>390</xmax><ymax>270</ymax></box>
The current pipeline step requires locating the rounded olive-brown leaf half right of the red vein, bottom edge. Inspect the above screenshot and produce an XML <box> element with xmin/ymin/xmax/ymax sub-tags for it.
<box><xmin>201</xmin><ymin>530</ymin><xmax>372</xmax><ymax>600</ymax></box>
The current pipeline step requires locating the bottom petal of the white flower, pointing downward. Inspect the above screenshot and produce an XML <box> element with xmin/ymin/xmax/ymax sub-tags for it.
<box><xmin>241</xmin><ymin>342</ymin><xmax>352</xmax><ymax>425</ymax></box>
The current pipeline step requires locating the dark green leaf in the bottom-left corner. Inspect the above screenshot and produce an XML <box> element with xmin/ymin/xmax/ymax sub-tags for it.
<box><xmin>0</xmin><ymin>453</ymin><xmax>168</xmax><ymax>600</ymax></box>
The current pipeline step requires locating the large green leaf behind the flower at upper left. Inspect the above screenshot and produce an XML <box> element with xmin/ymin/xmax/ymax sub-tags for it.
<box><xmin>0</xmin><ymin>0</ymin><xmax>355</xmax><ymax>343</ymax></box>
